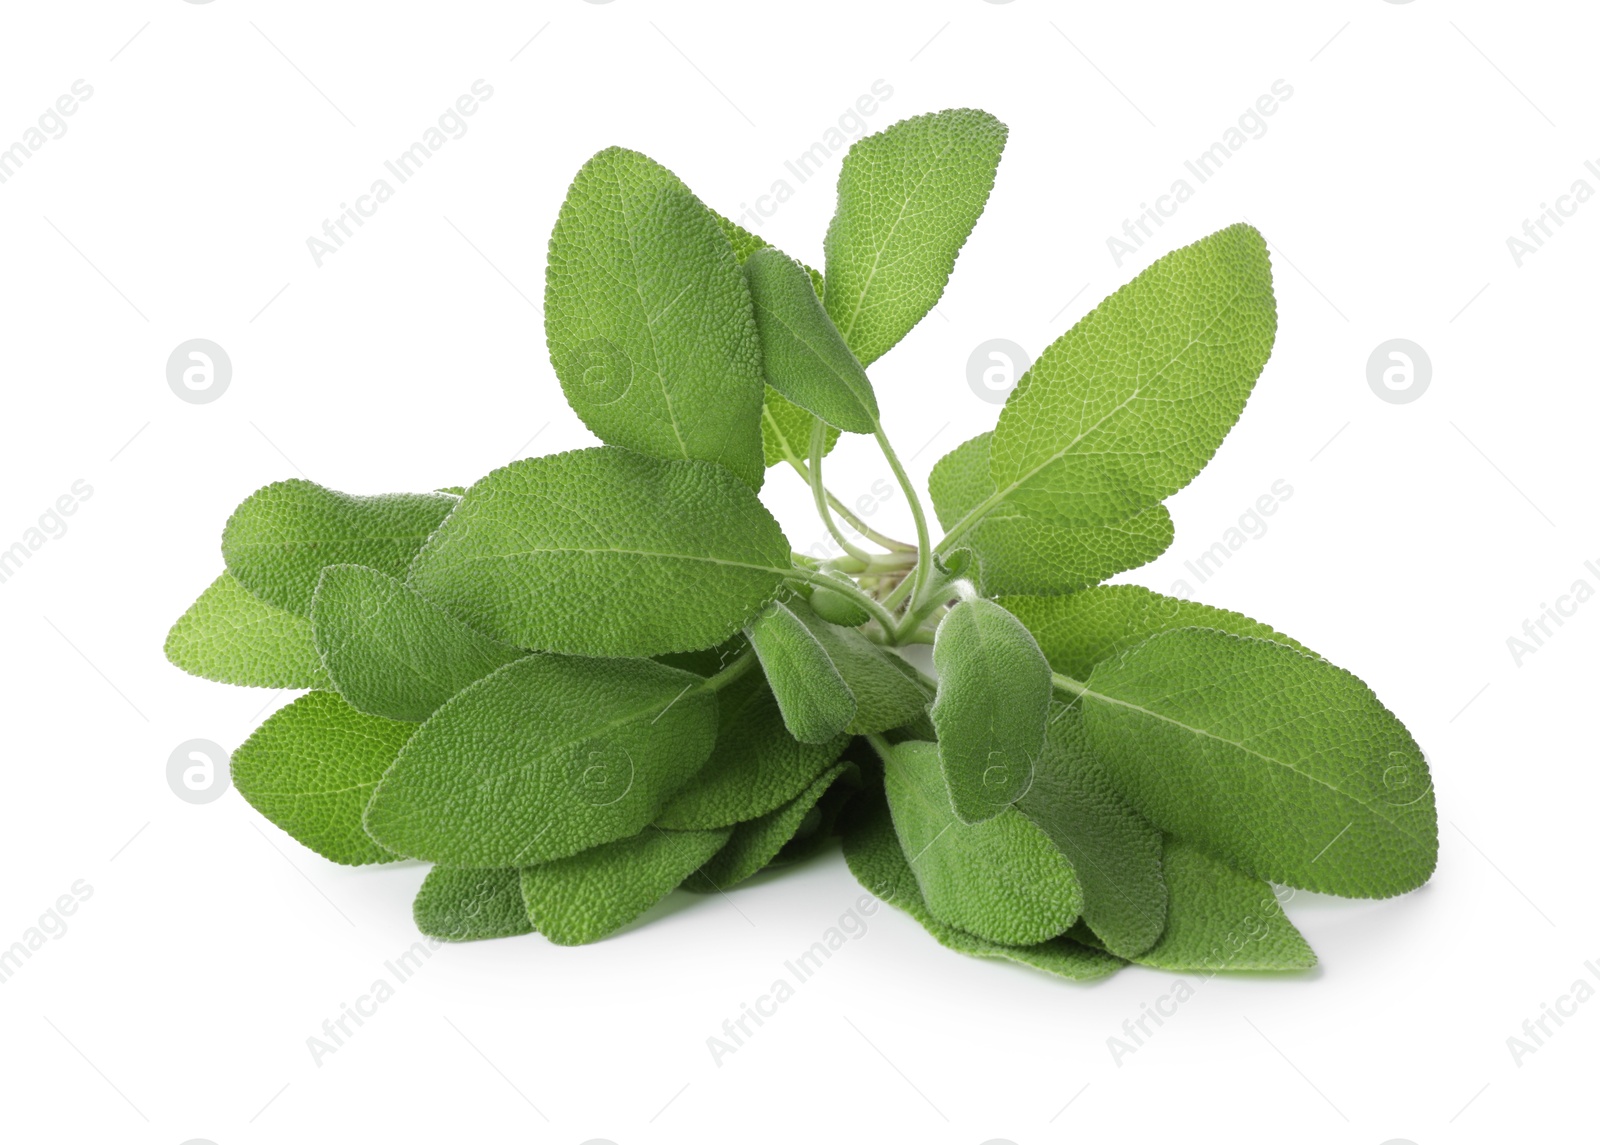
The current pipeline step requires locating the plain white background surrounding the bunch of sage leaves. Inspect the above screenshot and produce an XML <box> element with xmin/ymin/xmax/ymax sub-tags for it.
<box><xmin>0</xmin><ymin>0</ymin><xmax>1600</xmax><ymax>1145</ymax></box>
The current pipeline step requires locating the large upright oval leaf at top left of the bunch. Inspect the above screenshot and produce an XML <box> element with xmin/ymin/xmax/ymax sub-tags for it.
<box><xmin>544</xmin><ymin>147</ymin><xmax>765</xmax><ymax>488</ymax></box>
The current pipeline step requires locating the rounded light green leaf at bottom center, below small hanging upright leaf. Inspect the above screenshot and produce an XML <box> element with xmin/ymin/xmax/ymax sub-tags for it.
<box><xmin>883</xmin><ymin>740</ymin><xmax>1083</xmax><ymax>947</ymax></box>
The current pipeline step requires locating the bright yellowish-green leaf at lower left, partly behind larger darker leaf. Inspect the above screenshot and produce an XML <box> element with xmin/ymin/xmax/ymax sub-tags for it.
<box><xmin>232</xmin><ymin>692</ymin><xmax>416</xmax><ymax>867</ymax></box>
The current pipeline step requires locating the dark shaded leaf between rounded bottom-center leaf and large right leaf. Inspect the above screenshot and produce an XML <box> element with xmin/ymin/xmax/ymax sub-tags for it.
<box><xmin>1018</xmin><ymin>704</ymin><xmax>1166</xmax><ymax>958</ymax></box>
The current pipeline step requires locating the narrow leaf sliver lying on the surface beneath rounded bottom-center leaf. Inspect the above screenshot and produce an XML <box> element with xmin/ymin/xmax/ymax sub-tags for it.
<box><xmin>845</xmin><ymin>806</ymin><xmax>1123</xmax><ymax>982</ymax></box>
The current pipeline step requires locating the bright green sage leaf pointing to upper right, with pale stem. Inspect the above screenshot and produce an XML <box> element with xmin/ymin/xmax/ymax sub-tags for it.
<box><xmin>972</xmin><ymin>224</ymin><xmax>1277</xmax><ymax>533</ymax></box>
